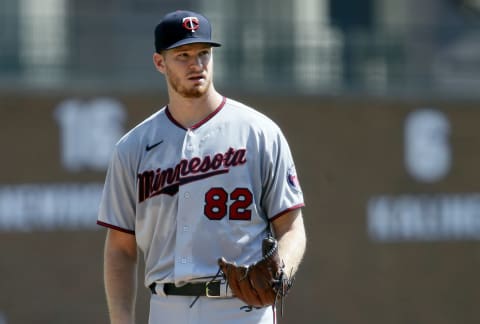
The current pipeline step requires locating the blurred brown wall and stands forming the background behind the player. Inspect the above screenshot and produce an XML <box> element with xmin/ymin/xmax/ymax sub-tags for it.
<box><xmin>0</xmin><ymin>0</ymin><xmax>480</xmax><ymax>324</ymax></box>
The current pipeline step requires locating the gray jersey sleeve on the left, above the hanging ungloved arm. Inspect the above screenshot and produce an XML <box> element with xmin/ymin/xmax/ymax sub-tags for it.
<box><xmin>97</xmin><ymin>145</ymin><xmax>136</xmax><ymax>234</ymax></box>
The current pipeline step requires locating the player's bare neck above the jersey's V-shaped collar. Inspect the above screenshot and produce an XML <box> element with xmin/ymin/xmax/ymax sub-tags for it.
<box><xmin>168</xmin><ymin>89</ymin><xmax>223</xmax><ymax>128</ymax></box>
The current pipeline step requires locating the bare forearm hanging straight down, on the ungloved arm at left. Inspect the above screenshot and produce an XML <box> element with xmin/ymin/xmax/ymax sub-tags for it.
<box><xmin>104</xmin><ymin>247</ymin><xmax>137</xmax><ymax>324</ymax></box>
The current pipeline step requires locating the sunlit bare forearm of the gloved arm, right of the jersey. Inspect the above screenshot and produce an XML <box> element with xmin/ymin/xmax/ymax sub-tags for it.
<box><xmin>277</xmin><ymin>215</ymin><xmax>306</xmax><ymax>276</ymax></box>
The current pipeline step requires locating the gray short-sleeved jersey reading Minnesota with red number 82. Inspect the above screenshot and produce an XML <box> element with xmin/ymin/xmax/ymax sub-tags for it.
<box><xmin>97</xmin><ymin>98</ymin><xmax>304</xmax><ymax>287</ymax></box>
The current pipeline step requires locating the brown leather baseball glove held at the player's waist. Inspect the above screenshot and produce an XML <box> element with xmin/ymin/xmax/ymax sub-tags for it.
<box><xmin>218</xmin><ymin>236</ymin><xmax>293</xmax><ymax>311</ymax></box>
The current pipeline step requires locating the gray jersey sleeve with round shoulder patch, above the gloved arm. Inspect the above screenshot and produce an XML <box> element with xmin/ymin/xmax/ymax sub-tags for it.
<box><xmin>262</xmin><ymin>129</ymin><xmax>304</xmax><ymax>220</ymax></box>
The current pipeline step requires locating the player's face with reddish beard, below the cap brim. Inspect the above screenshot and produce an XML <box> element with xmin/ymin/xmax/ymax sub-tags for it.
<box><xmin>154</xmin><ymin>43</ymin><xmax>213</xmax><ymax>98</ymax></box>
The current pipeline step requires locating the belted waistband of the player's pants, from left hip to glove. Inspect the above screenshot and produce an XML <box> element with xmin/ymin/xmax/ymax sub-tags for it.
<box><xmin>149</xmin><ymin>280</ymin><xmax>233</xmax><ymax>298</ymax></box>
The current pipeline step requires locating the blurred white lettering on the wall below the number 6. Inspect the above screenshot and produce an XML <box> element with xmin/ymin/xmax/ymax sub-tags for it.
<box><xmin>367</xmin><ymin>193</ymin><xmax>480</xmax><ymax>241</ymax></box>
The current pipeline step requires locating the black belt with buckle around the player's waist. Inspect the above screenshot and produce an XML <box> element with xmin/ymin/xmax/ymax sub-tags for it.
<box><xmin>150</xmin><ymin>281</ymin><xmax>221</xmax><ymax>297</ymax></box>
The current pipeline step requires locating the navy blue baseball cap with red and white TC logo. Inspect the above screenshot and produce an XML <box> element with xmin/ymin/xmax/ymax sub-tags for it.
<box><xmin>155</xmin><ymin>10</ymin><xmax>221</xmax><ymax>53</ymax></box>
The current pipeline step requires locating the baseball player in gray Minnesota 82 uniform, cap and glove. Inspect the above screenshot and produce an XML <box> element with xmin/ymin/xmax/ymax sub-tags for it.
<box><xmin>97</xmin><ymin>11</ymin><xmax>306</xmax><ymax>323</ymax></box>
